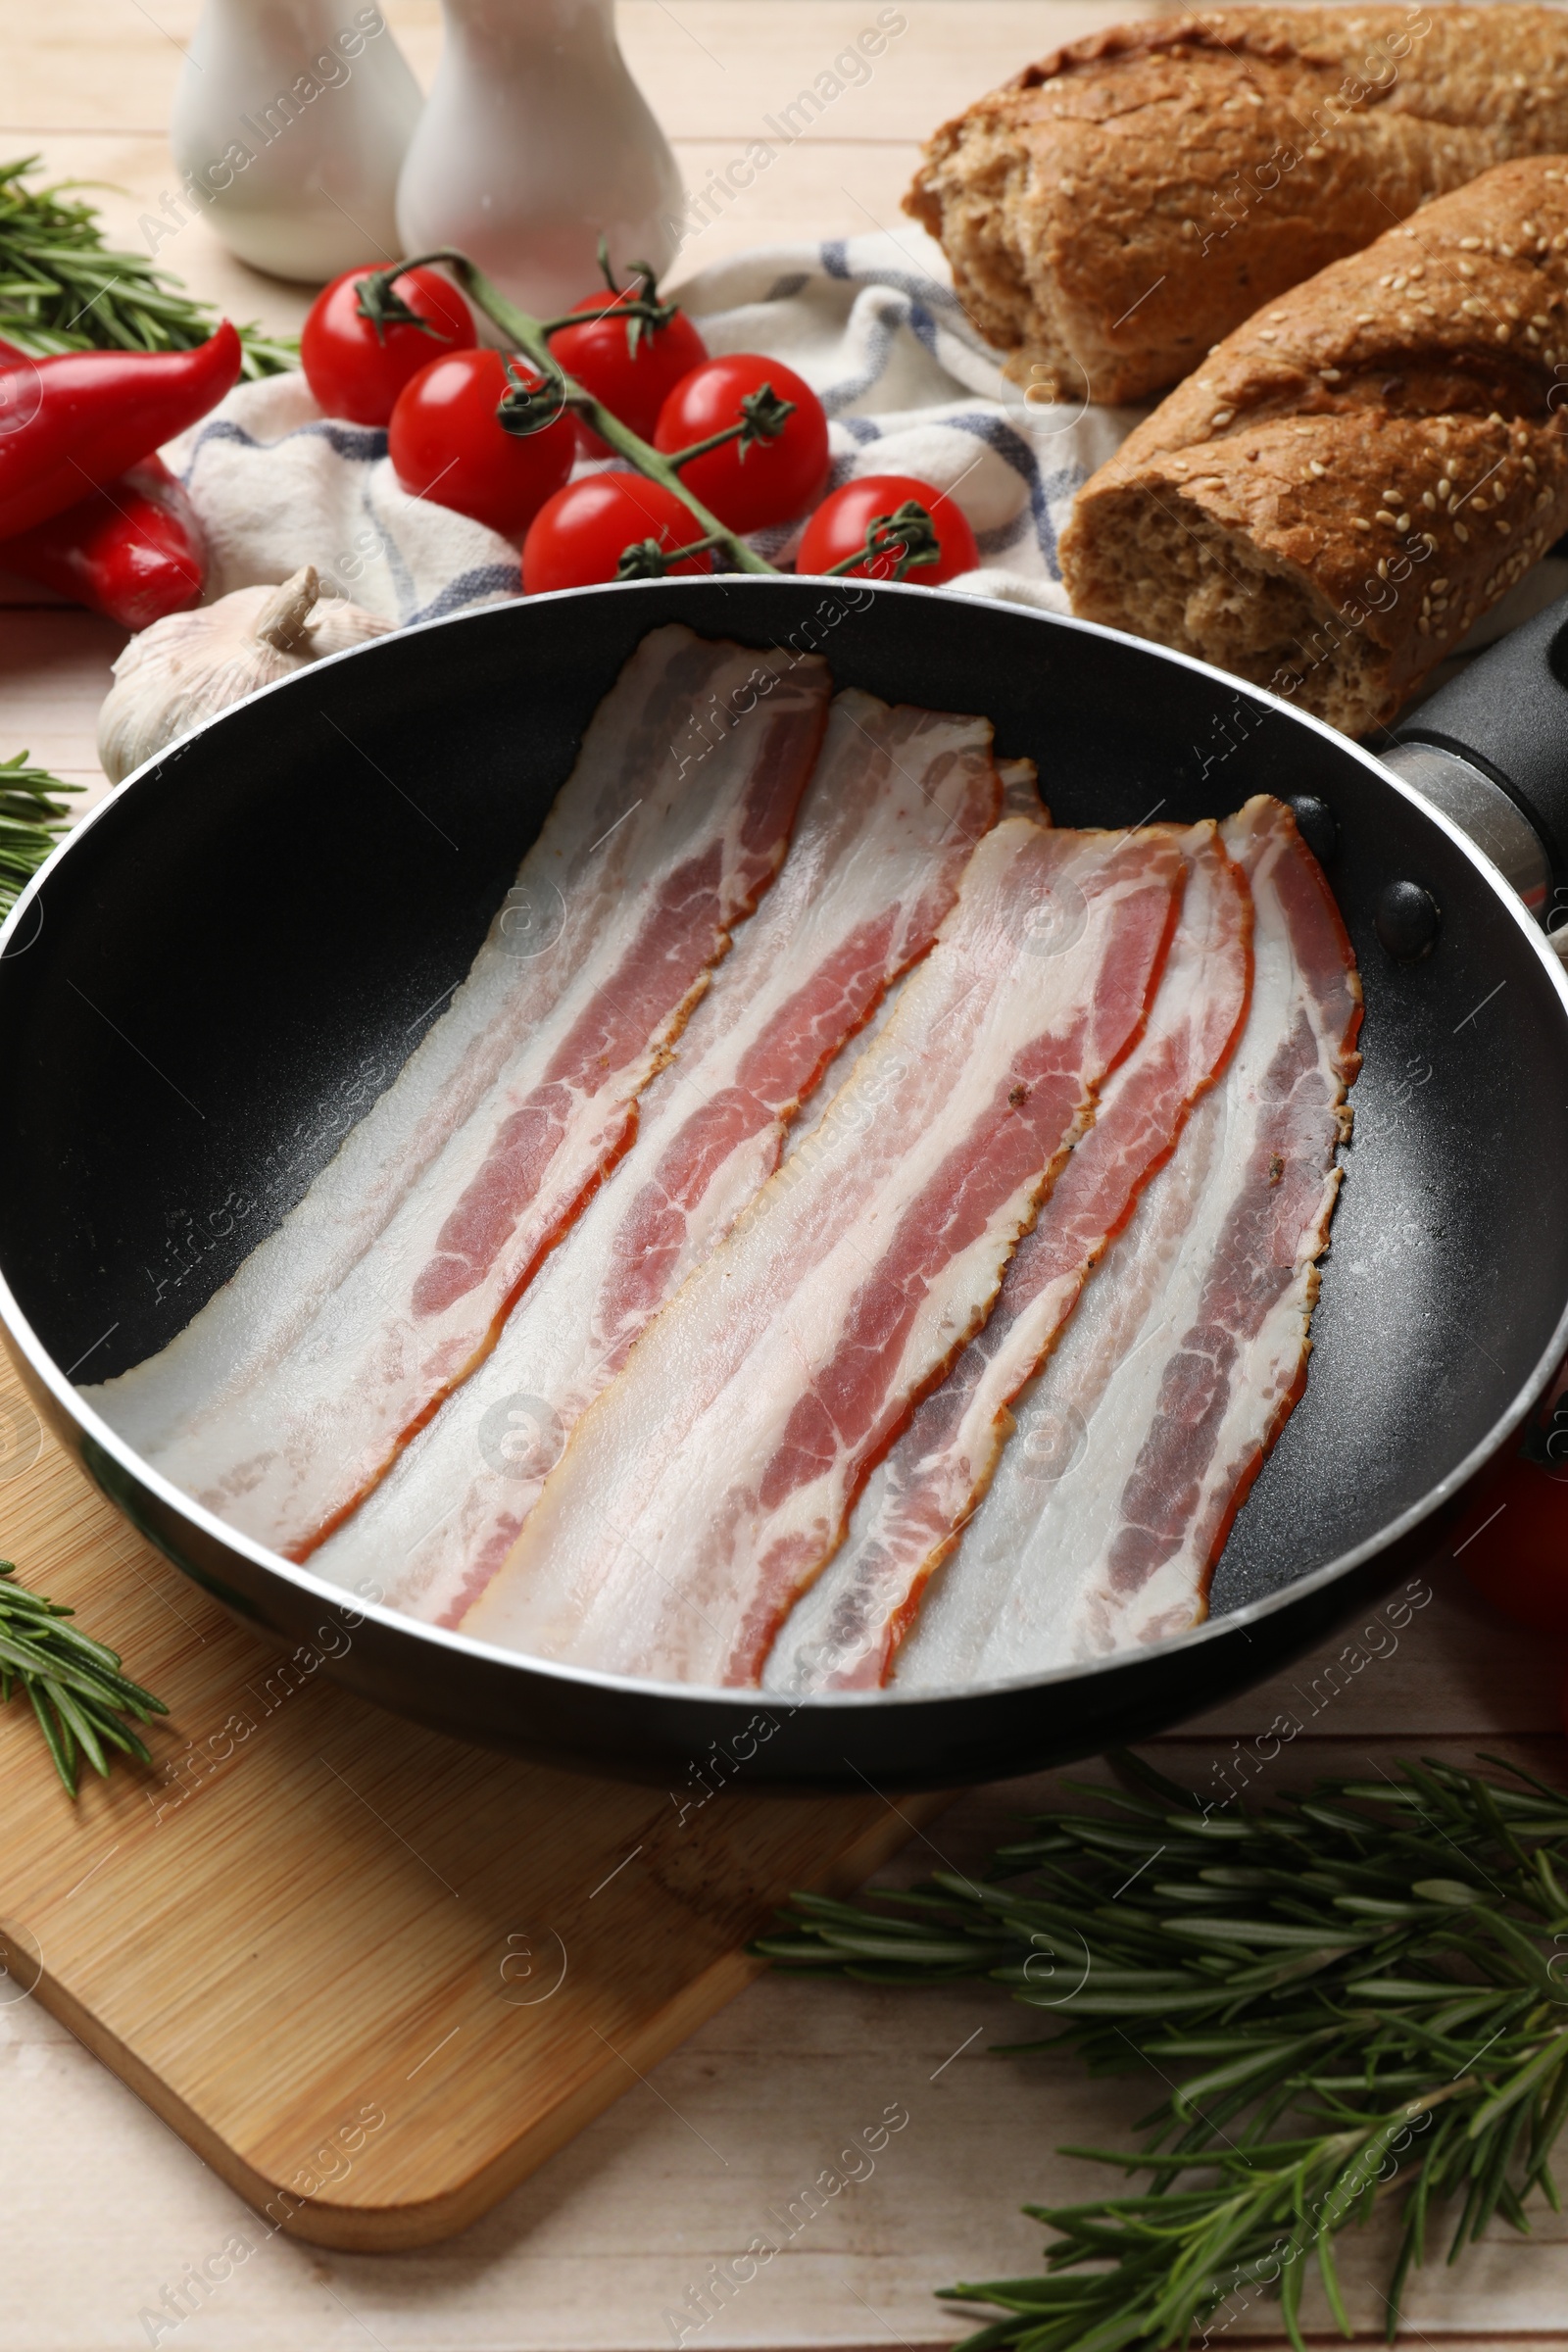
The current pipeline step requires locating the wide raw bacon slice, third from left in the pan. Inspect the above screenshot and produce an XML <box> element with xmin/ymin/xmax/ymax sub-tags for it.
<box><xmin>464</xmin><ymin>818</ymin><xmax>1185</xmax><ymax>1684</ymax></box>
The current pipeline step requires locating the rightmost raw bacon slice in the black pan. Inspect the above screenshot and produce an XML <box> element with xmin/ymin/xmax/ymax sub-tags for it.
<box><xmin>894</xmin><ymin>800</ymin><xmax>1361</xmax><ymax>1689</ymax></box>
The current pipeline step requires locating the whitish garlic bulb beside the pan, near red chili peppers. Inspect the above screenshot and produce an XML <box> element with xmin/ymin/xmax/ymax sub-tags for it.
<box><xmin>99</xmin><ymin>564</ymin><xmax>390</xmax><ymax>783</ymax></box>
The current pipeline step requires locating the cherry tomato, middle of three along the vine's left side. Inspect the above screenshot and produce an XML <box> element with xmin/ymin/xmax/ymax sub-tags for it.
<box><xmin>385</xmin><ymin>351</ymin><xmax>576</xmax><ymax>539</ymax></box>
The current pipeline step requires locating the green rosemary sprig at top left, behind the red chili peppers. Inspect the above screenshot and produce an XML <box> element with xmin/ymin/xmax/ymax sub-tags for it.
<box><xmin>0</xmin><ymin>155</ymin><xmax>299</xmax><ymax>376</ymax></box>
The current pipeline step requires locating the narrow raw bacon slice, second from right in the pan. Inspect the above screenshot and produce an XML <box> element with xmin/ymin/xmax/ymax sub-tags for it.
<box><xmin>780</xmin><ymin>823</ymin><xmax>1253</xmax><ymax>1691</ymax></box>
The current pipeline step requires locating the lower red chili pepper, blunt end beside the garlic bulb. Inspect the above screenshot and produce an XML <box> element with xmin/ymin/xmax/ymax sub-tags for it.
<box><xmin>0</xmin><ymin>457</ymin><xmax>207</xmax><ymax>628</ymax></box>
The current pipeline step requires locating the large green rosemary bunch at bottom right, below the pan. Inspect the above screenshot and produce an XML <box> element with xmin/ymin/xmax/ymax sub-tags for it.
<box><xmin>757</xmin><ymin>1757</ymin><xmax>1568</xmax><ymax>2352</ymax></box>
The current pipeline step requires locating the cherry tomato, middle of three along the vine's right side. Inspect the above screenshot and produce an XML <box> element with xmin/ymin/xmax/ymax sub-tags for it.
<box><xmin>654</xmin><ymin>351</ymin><xmax>827</xmax><ymax>531</ymax></box>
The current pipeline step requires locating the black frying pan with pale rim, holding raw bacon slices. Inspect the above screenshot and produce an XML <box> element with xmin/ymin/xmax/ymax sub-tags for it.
<box><xmin>0</xmin><ymin>576</ymin><xmax>1568</xmax><ymax>1789</ymax></box>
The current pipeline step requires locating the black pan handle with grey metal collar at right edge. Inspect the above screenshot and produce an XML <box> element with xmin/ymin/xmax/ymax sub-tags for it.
<box><xmin>1385</xmin><ymin>598</ymin><xmax>1568</xmax><ymax>927</ymax></box>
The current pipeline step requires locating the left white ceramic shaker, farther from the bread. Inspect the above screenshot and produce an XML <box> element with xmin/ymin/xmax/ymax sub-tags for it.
<box><xmin>170</xmin><ymin>0</ymin><xmax>420</xmax><ymax>282</ymax></box>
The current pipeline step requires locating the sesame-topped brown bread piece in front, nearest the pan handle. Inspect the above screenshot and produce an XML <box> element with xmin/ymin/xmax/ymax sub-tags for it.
<box><xmin>1060</xmin><ymin>155</ymin><xmax>1568</xmax><ymax>734</ymax></box>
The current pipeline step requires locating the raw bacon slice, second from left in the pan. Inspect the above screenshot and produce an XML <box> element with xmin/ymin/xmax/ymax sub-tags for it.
<box><xmin>313</xmin><ymin>689</ymin><xmax>1005</xmax><ymax>1623</ymax></box>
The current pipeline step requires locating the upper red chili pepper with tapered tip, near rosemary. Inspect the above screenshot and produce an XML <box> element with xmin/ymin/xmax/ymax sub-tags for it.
<box><xmin>0</xmin><ymin>319</ymin><xmax>240</xmax><ymax>539</ymax></box>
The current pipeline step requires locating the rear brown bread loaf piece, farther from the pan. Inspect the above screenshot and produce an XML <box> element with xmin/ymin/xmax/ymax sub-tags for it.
<box><xmin>906</xmin><ymin>0</ymin><xmax>1568</xmax><ymax>402</ymax></box>
